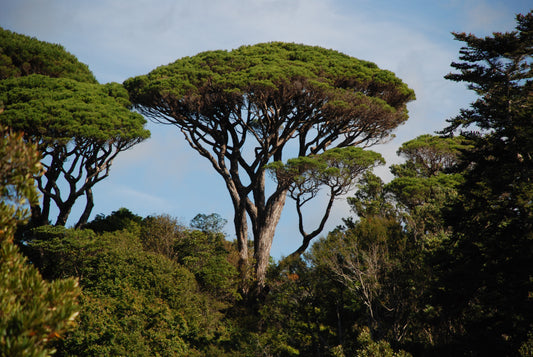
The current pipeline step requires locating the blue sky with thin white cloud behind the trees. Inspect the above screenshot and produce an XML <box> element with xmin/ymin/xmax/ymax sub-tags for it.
<box><xmin>0</xmin><ymin>0</ymin><xmax>533</xmax><ymax>258</ymax></box>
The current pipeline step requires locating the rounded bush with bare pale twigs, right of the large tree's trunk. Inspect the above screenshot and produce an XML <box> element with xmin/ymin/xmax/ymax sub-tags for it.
<box><xmin>309</xmin><ymin>216</ymin><xmax>422</xmax><ymax>342</ymax></box>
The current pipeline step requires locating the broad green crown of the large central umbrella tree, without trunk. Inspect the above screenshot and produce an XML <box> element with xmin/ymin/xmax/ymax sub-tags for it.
<box><xmin>124</xmin><ymin>42</ymin><xmax>414</xmax><ymax>156</ymax></box>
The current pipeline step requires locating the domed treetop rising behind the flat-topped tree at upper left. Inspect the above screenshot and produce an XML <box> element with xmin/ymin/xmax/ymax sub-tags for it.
<box><xmin>0</xmin><ymin>27</ymin><xmax>96</xmax><ymax>83</ymax></box>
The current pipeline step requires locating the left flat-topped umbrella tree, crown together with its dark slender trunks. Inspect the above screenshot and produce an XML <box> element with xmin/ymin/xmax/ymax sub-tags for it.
<box><xmin>0</xmin><ymin>74</ymin><xmax>149</xmax><ymax>225</ymax></box>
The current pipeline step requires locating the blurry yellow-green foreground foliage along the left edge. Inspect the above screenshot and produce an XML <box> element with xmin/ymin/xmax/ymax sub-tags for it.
<box><xmin>0</xmin><ymin>124</ymin><xmax>80</xmax><ymax>356</ymax></box>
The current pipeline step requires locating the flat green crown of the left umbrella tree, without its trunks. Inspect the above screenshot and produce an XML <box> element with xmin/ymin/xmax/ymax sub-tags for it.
<box><xmin>0</xmin><ymin>74</ymin><xmax>149</xmax><ymax>143</ymax></box>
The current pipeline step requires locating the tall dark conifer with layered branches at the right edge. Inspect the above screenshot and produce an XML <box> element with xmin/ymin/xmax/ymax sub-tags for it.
<box><xmin>434</xmin><ymin>12</ymin><xmax>533</xmax><ymax>355</ymax></box>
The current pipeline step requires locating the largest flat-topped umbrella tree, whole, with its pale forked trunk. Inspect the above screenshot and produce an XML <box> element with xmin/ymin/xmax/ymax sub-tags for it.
<box><xmin>124</xmin><ymin>42</ymin><xmax>414</xmax><ymax>285</ymax></box>
